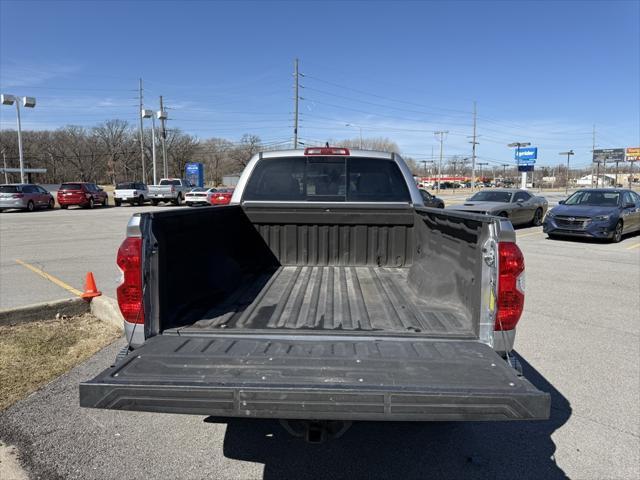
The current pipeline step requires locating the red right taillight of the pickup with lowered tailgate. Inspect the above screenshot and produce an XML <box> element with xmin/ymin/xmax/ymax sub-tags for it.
<box><xmin>495</xmin><ymin>242</ymin><xmax>524</xmax><ymax>330</ymax></box>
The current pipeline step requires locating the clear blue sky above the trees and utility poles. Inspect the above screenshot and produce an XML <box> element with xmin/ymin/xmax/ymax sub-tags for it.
<box><xmin>0</xmin><ymin>0</ymin><xmax>640</xmax><ymax>171</ymax></box>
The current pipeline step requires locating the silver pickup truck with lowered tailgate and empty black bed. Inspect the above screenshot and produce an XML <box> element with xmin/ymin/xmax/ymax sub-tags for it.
<box><xmin>80</xmin><ymin>148</ymin><xmax>550</xmax><ymax>440</ymax></box>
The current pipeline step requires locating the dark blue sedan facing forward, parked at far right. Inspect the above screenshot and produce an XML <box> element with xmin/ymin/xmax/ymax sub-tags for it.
<box><xmin>542</xmin><ymin>188</ymin><xmax>640</xmax><ymax>242</ymax></box>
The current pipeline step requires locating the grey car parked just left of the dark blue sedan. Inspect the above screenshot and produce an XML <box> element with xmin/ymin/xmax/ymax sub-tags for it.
<box><xmin>447</xmin><ymin>189</ymin><xmax>549</xmax><ymax>226</ymax></box>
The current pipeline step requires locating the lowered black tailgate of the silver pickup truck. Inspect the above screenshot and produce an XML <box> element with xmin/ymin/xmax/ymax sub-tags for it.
<box><xmin>80</xmin><ymin>334</ymin><xmax>550</xmax><ymax>421</ymax></box>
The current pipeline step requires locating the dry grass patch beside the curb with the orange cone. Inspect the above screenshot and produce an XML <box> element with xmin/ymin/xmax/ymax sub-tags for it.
<box><xmin>0</xmin><ymin>313</ymin><xmax>121</xmax><ymax>410</ymax></box>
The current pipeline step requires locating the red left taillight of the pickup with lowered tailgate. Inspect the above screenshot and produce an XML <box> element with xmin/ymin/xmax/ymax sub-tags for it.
<box><xmin>116</xmin><ymin>237</ymin><xmax>144</xmax><ymax>323</ymax></box>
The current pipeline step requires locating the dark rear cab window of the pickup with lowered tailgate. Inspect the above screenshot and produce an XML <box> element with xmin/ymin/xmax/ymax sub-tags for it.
<box><xmin>243</xmin><ymin>157</ymin><xmax>411</xmax><ymax>202</ymax></box>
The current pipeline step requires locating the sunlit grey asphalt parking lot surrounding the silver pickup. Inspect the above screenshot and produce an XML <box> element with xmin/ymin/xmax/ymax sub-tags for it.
<box><xmin>0</xmin><ymin>193</ymin><xmax>640</xmax><ymax>479</ymax></box>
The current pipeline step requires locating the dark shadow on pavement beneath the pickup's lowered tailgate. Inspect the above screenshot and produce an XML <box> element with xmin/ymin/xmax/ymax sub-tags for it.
<box><xmin>219</xmin><ymin>359</ymin><xmax>571</xmax><ymax>480</ymax></box>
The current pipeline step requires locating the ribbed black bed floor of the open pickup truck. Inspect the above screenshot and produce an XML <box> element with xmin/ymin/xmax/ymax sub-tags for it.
<box><xmin>170</xmin><ymin>266</ymin><xmax>474</xmax><ymax>338</ymax></box>
